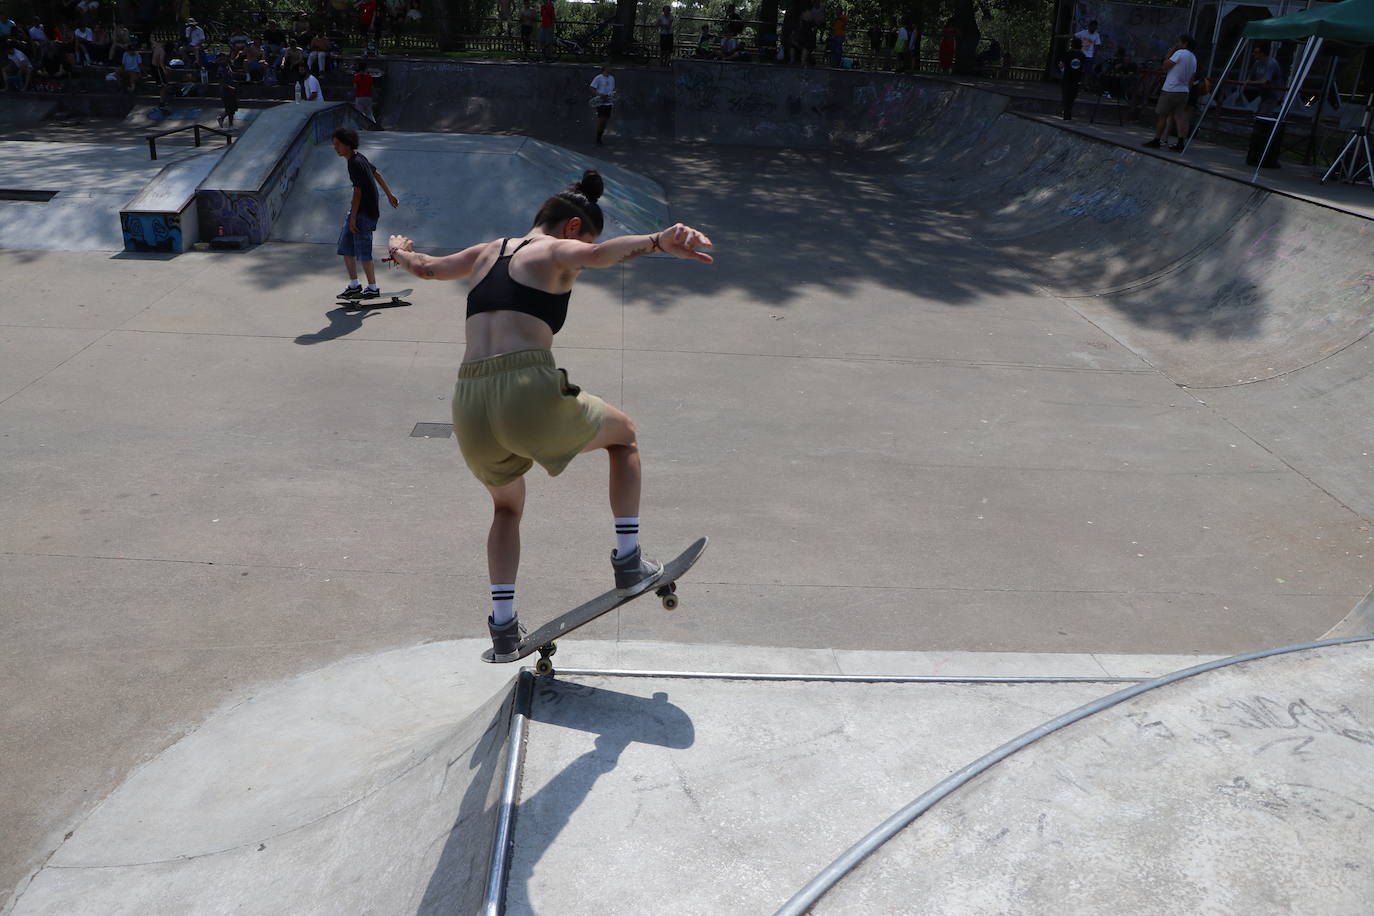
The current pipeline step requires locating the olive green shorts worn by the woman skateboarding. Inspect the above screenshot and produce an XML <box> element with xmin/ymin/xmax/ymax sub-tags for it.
<box><xmin>453</xmin><ymin>350</ymin><xmax>606</xmax><ymax>486</ymax></box>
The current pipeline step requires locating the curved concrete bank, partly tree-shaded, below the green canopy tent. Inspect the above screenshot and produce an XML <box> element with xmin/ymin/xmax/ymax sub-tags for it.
<box><xmin>899</xmin><ymin>87</ymin><xmax>1374</xmax><ymax>387</ymax></box>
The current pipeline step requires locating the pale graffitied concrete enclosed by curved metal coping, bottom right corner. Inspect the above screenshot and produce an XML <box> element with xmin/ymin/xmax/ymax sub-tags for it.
<box><xmin>787</xmin><ymin>641</ymin><xmax>1374</xmax><ymax>916</ymax></box>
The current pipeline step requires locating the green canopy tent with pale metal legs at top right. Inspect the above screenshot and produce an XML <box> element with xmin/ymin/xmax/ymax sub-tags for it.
<box><xmin>1184</xmin><ymin>0</ymin><xmax>1374</xmax><ymax>187</ymax></box>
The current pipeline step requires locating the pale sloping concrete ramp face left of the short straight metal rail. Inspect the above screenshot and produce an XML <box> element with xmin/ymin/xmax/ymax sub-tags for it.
<box><xmin>12</xmin><ymin>644</ymin><xmax>514</xmax><ymax>916</ymax></box>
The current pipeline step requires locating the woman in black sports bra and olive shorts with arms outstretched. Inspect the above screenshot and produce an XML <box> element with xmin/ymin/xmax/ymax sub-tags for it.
<box><xmin>389</xmin><ymin>170</ymin><xmax>712</xmax><ymax>662</ymax></box>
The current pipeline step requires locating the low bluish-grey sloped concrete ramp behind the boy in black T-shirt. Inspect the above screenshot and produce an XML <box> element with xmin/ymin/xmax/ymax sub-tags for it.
<box><xmin>272</xmin><ymin>132</ymin><xmax>669</xmax><ymax>250</ymax></box>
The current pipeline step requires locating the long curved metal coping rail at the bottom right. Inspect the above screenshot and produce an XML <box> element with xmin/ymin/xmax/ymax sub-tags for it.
<box><xmin>775</xmin><ymin>636</ymin><xmax>1374</xmax><ymax>916</ymax></box>
